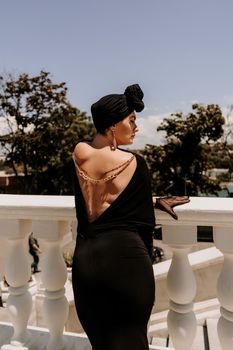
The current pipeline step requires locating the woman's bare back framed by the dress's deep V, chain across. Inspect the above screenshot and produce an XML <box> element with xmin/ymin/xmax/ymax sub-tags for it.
<box><xmin>73</xmin><ymin>142</ymin><xmax>137</xmax><ymax>222</ymax></box>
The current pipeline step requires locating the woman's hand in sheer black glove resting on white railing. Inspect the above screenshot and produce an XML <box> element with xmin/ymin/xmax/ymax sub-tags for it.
<box><xmin>155</xmin><ymin>196</ymin><xmax>190</xmax><ymax>220</ymax></box>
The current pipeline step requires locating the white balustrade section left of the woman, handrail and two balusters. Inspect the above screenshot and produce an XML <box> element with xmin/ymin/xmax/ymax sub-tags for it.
<box><xmin>0</xmin><ymin>195</ymin><xmax>75</xmax><ymax>350</ymax></box>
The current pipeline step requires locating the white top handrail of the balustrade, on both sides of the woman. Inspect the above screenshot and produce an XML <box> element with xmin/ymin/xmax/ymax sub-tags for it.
<box><xmin>0</xmin><ymin>194</ymin><xmax>233</xmax><ymax>226</ymax></box>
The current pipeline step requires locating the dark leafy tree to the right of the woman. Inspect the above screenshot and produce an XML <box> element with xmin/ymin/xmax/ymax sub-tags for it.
<box><xmin>142</xmin><ymin>104</ymin><xmax>224</xmax><ymax>195</ymax></box>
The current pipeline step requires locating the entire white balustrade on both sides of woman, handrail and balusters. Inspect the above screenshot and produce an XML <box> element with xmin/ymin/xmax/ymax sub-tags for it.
<box><xmin>0</xmin><ymin>195</ymin><xmax>233</xmax><ymax>350</ymax></box>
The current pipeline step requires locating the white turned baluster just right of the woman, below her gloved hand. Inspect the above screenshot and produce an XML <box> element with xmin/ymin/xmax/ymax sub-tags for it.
<box><xmin>162</xmin><ymin>225</ymin><xmax>197</xmax><ymax>350</ymax></box>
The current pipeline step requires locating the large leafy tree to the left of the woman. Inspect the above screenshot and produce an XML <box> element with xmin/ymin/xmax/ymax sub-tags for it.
<box><xmin>0</xmin><ymin>71</ymin><xmax>94</xmax><ymax>194</ymax></box>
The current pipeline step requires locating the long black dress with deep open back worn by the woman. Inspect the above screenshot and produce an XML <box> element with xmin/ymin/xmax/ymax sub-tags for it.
<box><xmin>72</xmin><ymin>151</ymin><xmax>155</xmax><ymax>350</ymax></box>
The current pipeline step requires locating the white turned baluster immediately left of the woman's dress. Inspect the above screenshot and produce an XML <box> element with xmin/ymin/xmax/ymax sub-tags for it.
<box><xmin>33</xmin><ymin>221</ymin><xmax>69</xmax><ymax>350</ymax></box>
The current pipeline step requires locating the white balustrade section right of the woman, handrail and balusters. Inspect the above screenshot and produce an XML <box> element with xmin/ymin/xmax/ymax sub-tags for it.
<box><xmin>157</xmin><ymin>197</ymin><xmax>233</xmax><ymax>350</ymax></box>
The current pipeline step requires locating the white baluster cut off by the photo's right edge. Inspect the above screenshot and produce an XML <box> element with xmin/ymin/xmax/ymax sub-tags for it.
<box><xmin>214</xmin><ymin>227</ymin><xmax>233</xmax><ymax>350</ymax></box>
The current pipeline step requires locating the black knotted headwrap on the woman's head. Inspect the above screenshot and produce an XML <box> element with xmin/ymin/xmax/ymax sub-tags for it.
<box><xmin>91</xmin><ymin>84</ymin><xmax>144</xmax><ymax>133</ymax></box>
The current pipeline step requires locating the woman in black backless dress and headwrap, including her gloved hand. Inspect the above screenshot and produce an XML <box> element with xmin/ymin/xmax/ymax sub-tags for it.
<box><xmin>72</xmin><ymin>84</ymin><xmax>188</xmax><ymax>350</ymax></box>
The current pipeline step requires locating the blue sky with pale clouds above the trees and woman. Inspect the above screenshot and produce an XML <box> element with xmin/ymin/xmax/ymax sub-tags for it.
<box><xmin>0</xmin><ymin>0</ymin><xmax>233</xmax><ymax>146</ymax></box>
